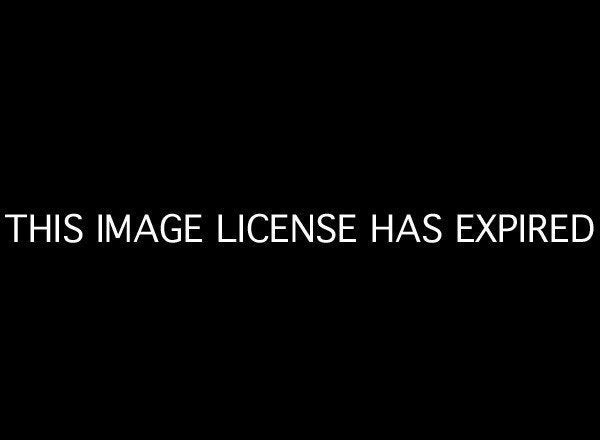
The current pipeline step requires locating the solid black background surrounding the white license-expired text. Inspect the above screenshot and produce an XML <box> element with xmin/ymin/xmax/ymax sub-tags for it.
<box><xmin>1</xmin><ymin>5</ymin><xmax>598</xmax><ymax>433</ymax></box>
